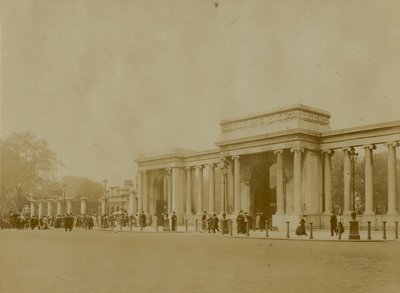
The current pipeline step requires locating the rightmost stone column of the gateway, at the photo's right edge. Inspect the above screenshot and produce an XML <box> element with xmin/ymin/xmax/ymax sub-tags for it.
<box><xmin>387</xmin><ymin>142</ymin><xmax>399</xmax><ymax>215</ymax></box>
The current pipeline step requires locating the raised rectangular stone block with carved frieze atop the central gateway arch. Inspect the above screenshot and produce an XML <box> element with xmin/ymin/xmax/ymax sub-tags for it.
<box><xmin>220</xmin><ymin>104</ymin><xmax>331</xmax><ymax>141</ymax></box>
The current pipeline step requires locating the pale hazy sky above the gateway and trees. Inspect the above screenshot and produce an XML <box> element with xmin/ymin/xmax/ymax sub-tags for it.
<box><xmin>0</xmin><ymin>0</ymin><xmax>400</xmax><ymax>185</ymax></box>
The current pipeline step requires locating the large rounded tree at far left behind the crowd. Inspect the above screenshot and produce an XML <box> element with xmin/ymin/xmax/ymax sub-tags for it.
<box><xmin>0</xmin><ymin>132</ymin><xmax>61</xmax><ymax>213</ymax></box>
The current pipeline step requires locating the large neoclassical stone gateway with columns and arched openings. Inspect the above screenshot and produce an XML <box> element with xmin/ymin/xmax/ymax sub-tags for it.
<box><xmin>135</xmin><ymin>105</ymin><xmax>400</xmax><ymax>229</ymax></box>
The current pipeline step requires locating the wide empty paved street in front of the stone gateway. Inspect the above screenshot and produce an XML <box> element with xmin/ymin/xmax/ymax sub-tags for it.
<box><xmin>0</xmin><ymin>230</ymin><xmax>400</xmax><ymax>293</ymax></box>
